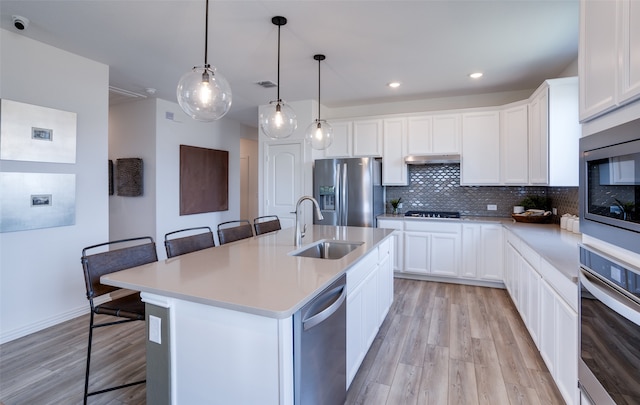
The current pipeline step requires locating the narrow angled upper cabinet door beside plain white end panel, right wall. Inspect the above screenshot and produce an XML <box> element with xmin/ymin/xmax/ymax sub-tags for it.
<box><xmin>529</xmin><ymin>88</ymin><xmax>552</xmax><ymax>185</ymax></box>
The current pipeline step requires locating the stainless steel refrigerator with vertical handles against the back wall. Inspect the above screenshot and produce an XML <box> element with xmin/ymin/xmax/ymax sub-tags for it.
<box><xmin>313</xmin><ymin>157</ymin><xmax>384</xmax><ymax>227</ymax></box>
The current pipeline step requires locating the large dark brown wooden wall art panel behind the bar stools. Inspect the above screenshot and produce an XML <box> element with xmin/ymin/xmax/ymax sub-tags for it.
<box><xmin>180</xmin><ymin>145</ymin><xmax>229</xmax><ymax>215</ymax></box>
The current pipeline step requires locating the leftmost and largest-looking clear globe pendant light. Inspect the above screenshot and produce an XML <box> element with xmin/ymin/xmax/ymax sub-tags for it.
<box><xmin>176</xmin><ymin>0</ymin><xmax>231</xmax><ymax>122</ymax></box>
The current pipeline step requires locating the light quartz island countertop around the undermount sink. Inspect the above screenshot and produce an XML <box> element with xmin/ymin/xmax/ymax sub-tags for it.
<box><xmin>100</xmin><ymin>225</ymin><xmax>393</xmax><ymax>319</ymax></box>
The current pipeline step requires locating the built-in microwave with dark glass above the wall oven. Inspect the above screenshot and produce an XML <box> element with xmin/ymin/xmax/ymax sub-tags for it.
<box><xmin>580</xmin><ymin>119</ymin><xmax>640</xmax><ymax>254</ymax></box>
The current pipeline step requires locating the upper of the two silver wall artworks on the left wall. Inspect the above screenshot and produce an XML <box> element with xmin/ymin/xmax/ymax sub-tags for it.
<box><xmin>0</xmin><ymin>99</ymin><xmax>77</xmax><ymax>163</ymax></box>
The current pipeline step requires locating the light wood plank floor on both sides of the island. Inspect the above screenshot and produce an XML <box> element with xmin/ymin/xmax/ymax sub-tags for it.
<box><xmin>0</xmin><ymin>279</ymin><xmax>564</xmax><ymax>405</ymax></box>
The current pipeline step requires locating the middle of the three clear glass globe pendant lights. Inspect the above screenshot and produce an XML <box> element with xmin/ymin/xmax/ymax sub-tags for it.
<box><xmin>259</xmin><ymin>16</ymin><xmax>298</xmax><ymax>139</ymax></box>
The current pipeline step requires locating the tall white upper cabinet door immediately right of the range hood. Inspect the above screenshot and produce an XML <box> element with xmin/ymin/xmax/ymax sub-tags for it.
<box><xmin>460</xmin><ymin>110</ymin><xmax>500</xmax><ymax>185</ymax></box>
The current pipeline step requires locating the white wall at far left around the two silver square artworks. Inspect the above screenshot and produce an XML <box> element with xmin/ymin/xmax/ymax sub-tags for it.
<box><xmin>0</xmin><ymin>30</ymin><xmax>109</xmax><ymax>343</ymax></box>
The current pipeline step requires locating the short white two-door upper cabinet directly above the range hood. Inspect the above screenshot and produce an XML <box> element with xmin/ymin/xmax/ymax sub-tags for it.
<box><xmin>407</xmin><ymin>114</ymin><xmax>462</xmax><ymax>155</ymax></box>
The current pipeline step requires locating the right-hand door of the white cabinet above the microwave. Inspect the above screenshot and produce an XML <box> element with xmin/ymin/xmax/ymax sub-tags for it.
<box><xmin>620</xmin><ymin>0</ymin><xmax>640</xmax><ymax>103</ymax></box>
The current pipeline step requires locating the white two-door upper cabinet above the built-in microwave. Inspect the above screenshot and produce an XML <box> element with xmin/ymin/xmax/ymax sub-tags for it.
<box><xmin>578</xmin><ymin>0</ymin><xmax>640</xmax><ymax>122</ymax></box>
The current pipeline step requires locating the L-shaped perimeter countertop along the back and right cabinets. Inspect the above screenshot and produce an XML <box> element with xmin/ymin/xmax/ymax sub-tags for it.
<box><xmin>378</xmin><ymin>214</ymin><xmax>582</xmax><ymax>282</ymax></box>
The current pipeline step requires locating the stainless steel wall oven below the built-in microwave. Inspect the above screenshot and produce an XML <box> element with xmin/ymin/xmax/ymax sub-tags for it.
<box><xmin>578</xmin><ymin>246</ymin><xmax>640</xmax><ymax>405</ymax></box>
